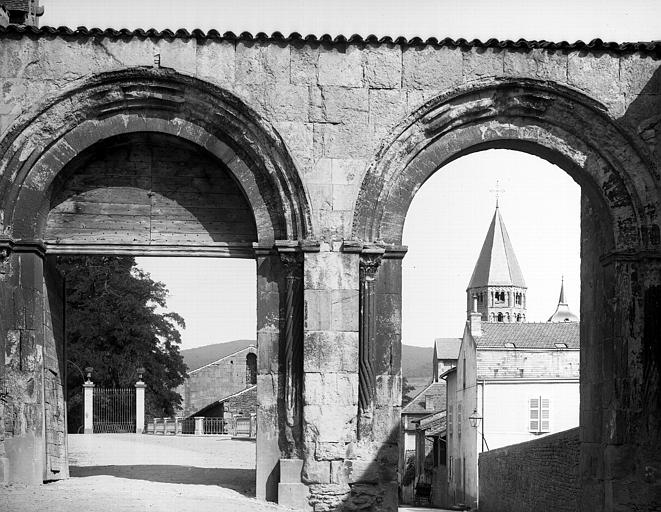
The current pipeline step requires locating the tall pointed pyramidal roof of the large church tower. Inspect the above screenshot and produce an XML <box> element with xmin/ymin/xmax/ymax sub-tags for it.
<box><xmin>468</xmin><ymin>206</ymin><xmax>526</xmax><ymax>288</ymax></box>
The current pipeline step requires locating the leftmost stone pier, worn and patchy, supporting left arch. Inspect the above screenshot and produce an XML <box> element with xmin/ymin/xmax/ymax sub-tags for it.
<box><xmin>0</xmin><ymin>239</ymin><xmax>46</xmax><ymax>485</ymax></box>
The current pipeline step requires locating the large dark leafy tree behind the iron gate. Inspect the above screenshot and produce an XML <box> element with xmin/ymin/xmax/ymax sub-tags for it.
<box><xmin>58</xmin><ymin>256</ymin><xmax>186</xmax><ymax>431</ymax></box>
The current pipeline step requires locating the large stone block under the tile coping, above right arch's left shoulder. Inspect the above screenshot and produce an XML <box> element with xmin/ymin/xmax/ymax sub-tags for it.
<box><xmin>402</xmin><ymin>46</ymin><xmax>463</xmax><ymax>89</ymax></box>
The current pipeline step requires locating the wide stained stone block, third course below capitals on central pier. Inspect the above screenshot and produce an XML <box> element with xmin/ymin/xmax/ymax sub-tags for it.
<box><xmin>303</xmin><ymin>331</ymin><xmax>358</xmax><ymax>372</ymax></box>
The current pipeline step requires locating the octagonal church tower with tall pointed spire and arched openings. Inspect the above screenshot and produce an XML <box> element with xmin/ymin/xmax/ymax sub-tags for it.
<box><xmin>466</xmin><ymin>203</ymin><xmax>527</xmax><ymax>322</ymax></box>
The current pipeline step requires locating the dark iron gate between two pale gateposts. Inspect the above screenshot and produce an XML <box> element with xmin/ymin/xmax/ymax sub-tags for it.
<box><xmin>93</xmin><ymin>388</ymin><xmax>135</xmax><ymax>434</ymax></box>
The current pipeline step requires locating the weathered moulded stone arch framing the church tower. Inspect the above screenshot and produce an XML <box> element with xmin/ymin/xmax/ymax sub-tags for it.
<box><xmin>353</xmin><ymin>79</ymin><xmax>656</xmax><ymax>252</ymax></box>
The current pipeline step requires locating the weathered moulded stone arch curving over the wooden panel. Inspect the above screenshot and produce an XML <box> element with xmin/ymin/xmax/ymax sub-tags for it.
<box><xmin>0</xmin><ymin>68</ymin><xmax>311</xmax><ymax>244</ymax></box>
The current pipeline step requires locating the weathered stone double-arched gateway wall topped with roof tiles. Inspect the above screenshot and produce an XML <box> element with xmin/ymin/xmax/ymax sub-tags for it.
<box><xmin>0</xmin><ymin>25</ymin><xmax>661</xmax><ymax>512</ymax></box>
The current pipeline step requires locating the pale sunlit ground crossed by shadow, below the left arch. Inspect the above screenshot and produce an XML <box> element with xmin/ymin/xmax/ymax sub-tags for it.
<box><xmin>0</xmin><ymin>434</ymin><xmax>454</xmax><ymax>512</ymax></box>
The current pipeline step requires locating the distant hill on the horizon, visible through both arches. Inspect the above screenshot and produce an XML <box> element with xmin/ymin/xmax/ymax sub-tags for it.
<box><xmin>181</xmin><ymin>340</ymin><xmax>434</xmax><ymax>388</ymax></box>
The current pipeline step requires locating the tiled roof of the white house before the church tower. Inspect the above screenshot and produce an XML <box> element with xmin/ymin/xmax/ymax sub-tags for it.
<box><xmin>475</xmin><ymin>322</ymin><xmax>580</xmax><ymax>349</ymax></box>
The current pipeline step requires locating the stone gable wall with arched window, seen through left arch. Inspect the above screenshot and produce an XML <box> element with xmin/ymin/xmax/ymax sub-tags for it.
<box><xmin>177</xmin><ymin>346</ymin><xmax>256</xmax><ymax>416</ymax></box>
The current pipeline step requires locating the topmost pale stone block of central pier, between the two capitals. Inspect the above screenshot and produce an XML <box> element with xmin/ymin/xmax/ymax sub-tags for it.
<box><xmin>304</xmin><ymin>252</ymin><xmax>359</xmax><ymax>290</ymax></box>
